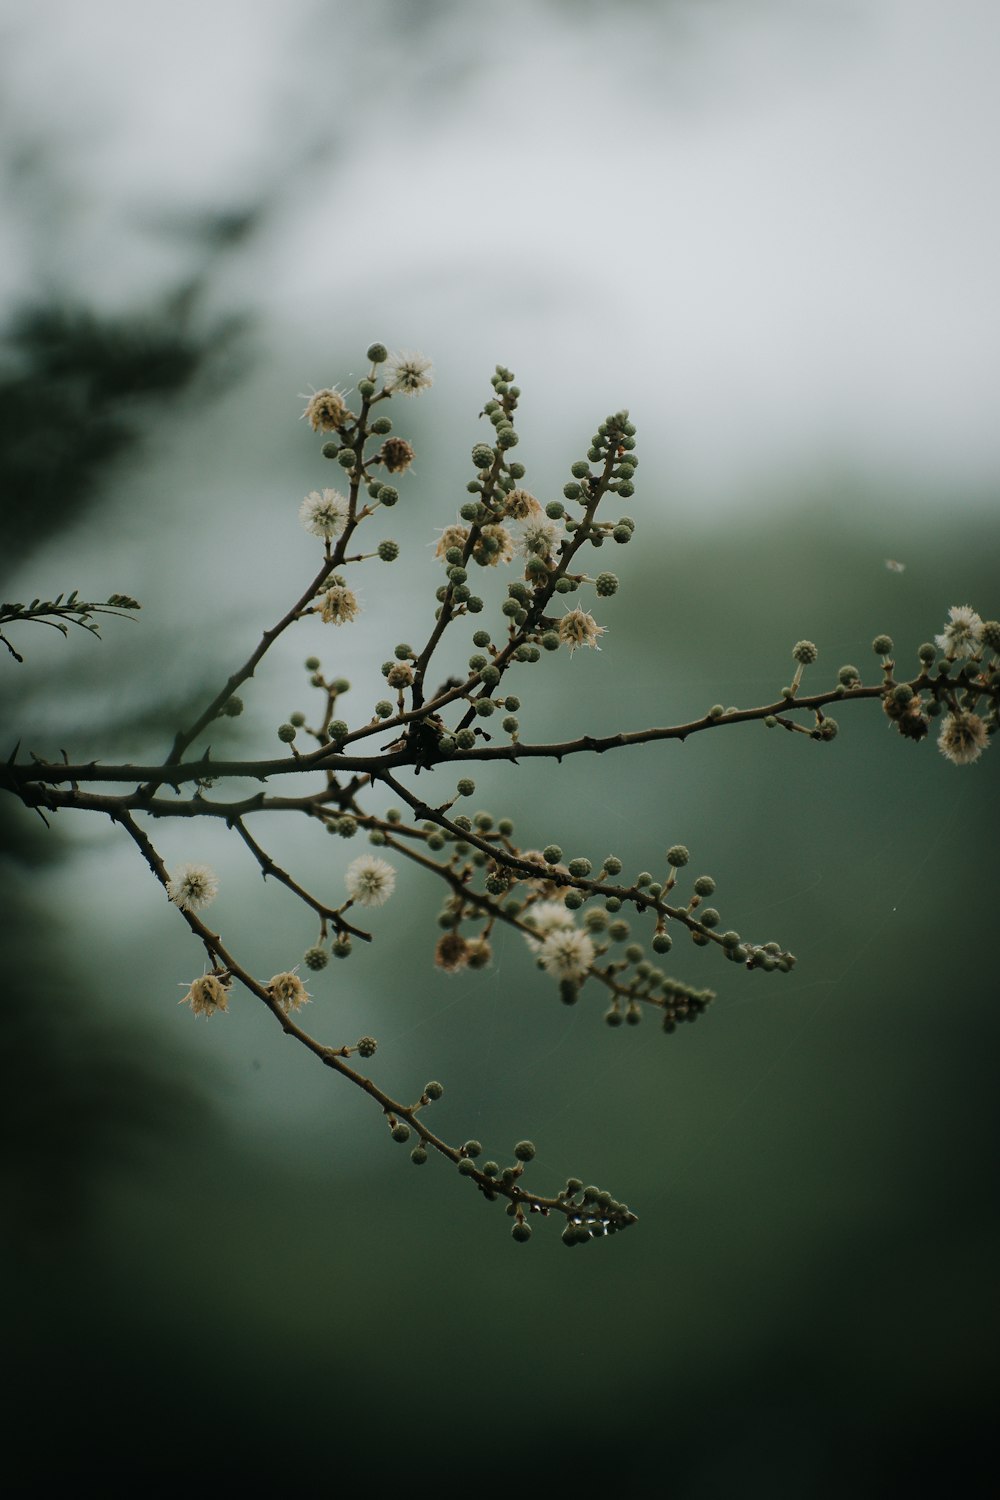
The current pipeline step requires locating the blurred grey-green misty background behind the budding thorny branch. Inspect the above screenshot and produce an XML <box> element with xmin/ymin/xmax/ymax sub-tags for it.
<box><xmin>0</xmin><ymin>0</ymin><xmax>1000</xmax><ymax>1500</ymax></box>
